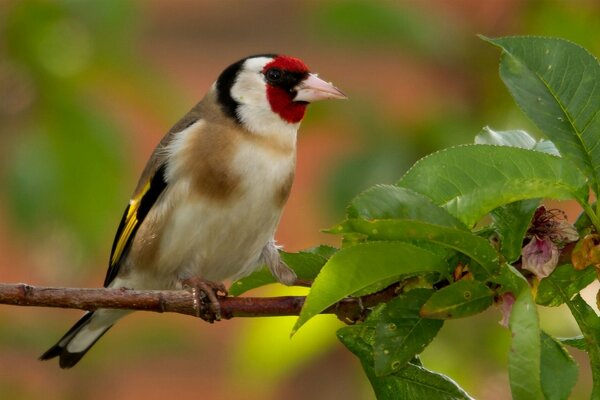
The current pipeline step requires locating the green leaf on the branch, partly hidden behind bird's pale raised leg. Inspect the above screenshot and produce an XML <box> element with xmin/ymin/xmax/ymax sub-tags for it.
<box><xmin>229</xmin><ymin>250</ymin><xmax>332</xmax><ymax>296</ymax></box>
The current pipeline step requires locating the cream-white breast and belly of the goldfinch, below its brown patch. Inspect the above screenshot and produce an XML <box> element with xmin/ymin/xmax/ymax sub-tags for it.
<box><xmin>158</xmin><ymin>133</ymin><xmax>295</xmax><ymax>281</ymax></box>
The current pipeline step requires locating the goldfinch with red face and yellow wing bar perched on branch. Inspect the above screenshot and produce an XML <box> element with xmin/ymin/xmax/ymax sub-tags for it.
<box><xmin>40</xmin><ymin>54</ymin><xmax>346</xmax><ymax>368</ymax></box>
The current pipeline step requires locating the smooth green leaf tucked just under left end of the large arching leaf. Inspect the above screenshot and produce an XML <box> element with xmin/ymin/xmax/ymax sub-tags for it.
<box><xmin>347</xmin><ymin>185</ymin><xmax>466</xmax><ymax>229</ymax></box>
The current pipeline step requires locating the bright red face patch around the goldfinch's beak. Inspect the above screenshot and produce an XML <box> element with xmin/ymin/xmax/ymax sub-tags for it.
<box><xmin>263</xmin><ymin>56</ymin><xmax>308</xmax><ymax>123</ymax></box>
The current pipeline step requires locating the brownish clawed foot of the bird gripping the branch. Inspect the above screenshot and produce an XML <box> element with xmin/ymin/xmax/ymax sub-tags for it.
<box><xmin>181</xmin><ymin>277</ymin><xmax>228</xmax><ymax>324</ymax></box>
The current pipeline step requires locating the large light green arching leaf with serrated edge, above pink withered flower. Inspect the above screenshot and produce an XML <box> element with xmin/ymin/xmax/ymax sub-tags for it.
<box><xmin>398</xmin><ymin>145</ymin><xmax>587</xmax><ymax>226</ymax></box>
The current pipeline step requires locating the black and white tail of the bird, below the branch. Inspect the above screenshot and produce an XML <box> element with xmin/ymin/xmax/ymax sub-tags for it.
<box><xmin>40</xmin><ymin>309</ymin><xmax>128</xmax><ymax>368</ymax></box>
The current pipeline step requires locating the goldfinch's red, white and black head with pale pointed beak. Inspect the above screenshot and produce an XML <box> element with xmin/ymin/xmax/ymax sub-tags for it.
<box><xmin>216</xmin><ymin>54</ymin><xmax>346</xmax><ymax>133</ymax></box>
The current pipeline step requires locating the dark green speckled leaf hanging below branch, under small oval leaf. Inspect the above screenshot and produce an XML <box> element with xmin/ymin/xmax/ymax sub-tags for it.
<box><xmin>365</xmin><ymin>289</ymin><xmax>443</xmax><ymax>376</ymax></box>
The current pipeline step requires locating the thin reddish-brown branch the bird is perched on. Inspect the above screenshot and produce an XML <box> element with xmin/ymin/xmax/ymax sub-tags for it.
<box><xmin>0</xmin><ymin>283</ymin><xmax>398</xmax><ymax>322</ymax></box>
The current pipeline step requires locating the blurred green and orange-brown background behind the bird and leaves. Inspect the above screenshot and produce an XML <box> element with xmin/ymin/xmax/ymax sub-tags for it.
<box><xmin>0</xmin><ymin>0</ymin><xmax>600</xmax><ymax>400</ymax></box>
